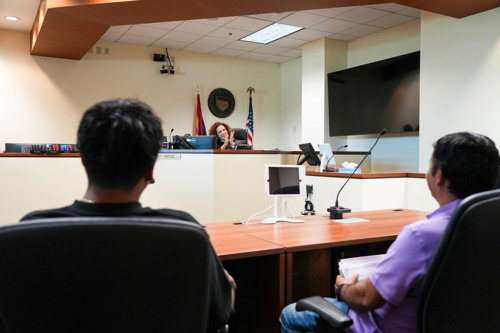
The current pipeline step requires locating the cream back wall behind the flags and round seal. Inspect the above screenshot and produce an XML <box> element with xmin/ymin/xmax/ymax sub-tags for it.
<box><xmin>0</xmin><ymin>30</ymin><xmax>281</xmax><ymax>149</ymax></box>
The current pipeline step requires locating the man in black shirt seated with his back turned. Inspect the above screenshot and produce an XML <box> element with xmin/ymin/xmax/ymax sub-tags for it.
<box><xmin>21</xmin><ymin>99</ymin><xmax>236</xmax><ymax>329</ymax></box>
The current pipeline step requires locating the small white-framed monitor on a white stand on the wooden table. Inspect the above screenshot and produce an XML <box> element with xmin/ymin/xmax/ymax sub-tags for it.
<box><xmin>262</xmin><ymin>164</ymin><xmax>306</xmax><ymax>223</ymax></box>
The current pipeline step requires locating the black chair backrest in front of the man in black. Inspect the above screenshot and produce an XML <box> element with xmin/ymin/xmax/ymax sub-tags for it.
<box><xmin>0</xmin><ymin>217</ymin><xmax>211</xmax><ymax>333</ymax></box>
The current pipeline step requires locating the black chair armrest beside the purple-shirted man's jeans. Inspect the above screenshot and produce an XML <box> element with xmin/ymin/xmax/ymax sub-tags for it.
<box><xmin>295</xmin><ymin>296</ymin><xmax>352</xmax><ymax>328</ymax></box>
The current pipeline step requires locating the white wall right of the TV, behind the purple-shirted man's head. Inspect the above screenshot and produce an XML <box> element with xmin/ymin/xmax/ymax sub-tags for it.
<box><xmin>419</xmin><ymin>8</ymin><xmax>500</xmax><ymax>172</ymax></box>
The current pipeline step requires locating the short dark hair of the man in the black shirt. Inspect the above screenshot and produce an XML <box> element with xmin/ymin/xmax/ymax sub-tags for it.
<box><xmin>77</xmin><ymin>99</ymin><xmax>163</xmax><ymax>189</ymax></box>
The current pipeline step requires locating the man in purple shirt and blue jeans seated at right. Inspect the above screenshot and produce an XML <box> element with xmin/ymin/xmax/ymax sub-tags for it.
<box><xmin>280</xmin><ymin>132</ymin><xmax>500</xmax><ymax>333</ymax></box>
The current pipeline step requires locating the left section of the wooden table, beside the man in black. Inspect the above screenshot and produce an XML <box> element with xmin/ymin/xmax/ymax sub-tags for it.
<box><xmin>206</xmin><ymin>223</ymin><xmax>285</xmax><ymax>333</ymax></box>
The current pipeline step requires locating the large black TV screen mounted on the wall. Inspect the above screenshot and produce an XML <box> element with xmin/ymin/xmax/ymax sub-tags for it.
<box><xmin>328</xmin><ymin>52</ymin><xmax>420</xmax><ymax>136</ymax></box>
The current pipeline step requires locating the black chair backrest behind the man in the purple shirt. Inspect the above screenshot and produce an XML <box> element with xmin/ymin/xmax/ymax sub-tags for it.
<box><xmin>417</xmin><ymin>190</ymin><xmax>500</xmax><ymax>332</ymax></box>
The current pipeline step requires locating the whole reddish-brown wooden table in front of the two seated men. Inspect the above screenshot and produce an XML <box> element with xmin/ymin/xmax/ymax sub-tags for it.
<box><xmin>206</xmin><ymin>209</ymin><xmax>427</xmax><ymax>332</ymax></box>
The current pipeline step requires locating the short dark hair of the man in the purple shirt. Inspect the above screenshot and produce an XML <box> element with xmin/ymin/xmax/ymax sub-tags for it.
<box><xmin>432</xmin><ymin>132</ymin><xmax>500</xmax><ymax>198</ymax></box>
